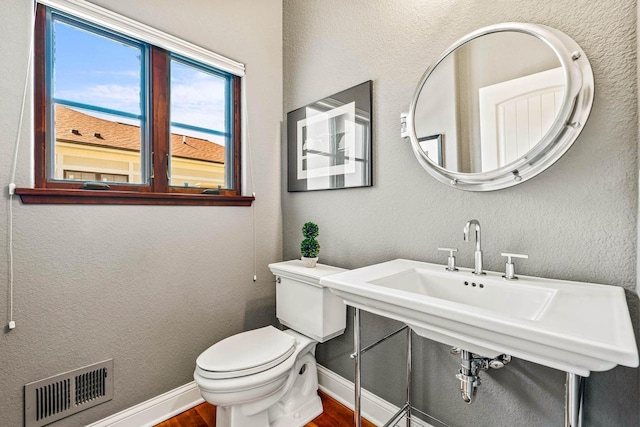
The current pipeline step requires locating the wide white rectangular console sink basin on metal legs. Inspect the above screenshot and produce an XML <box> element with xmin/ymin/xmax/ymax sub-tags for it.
<box><xmin>321</xmin><ymin>259</ymin><xmax>638</xmax><ymax>376</ymax></box>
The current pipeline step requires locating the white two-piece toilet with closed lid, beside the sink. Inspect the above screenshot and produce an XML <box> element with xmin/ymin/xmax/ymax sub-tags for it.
<box><xmin>193</xmin><ymin>260</ymin><xmax>346</xmax><ymax>427</ymax></box>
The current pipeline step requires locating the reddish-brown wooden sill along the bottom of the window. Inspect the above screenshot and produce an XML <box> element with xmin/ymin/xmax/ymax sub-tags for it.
<box><xmin>16</xmin><ymin>188</ymin><xmax>255</xmax><ymax>206</ymax></box>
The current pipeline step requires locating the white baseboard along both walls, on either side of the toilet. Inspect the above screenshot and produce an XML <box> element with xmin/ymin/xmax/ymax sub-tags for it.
<box><xmin>87</xmin><ymin>365</ymin><xmax>433</xmax><ymax>427</ymax></box>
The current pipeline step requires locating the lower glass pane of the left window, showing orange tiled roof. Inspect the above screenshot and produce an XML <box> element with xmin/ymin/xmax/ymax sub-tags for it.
<box><xmin>53</xmin><ymin>105</ymin><xmax>143</xmax><ymax>184</ymax></box>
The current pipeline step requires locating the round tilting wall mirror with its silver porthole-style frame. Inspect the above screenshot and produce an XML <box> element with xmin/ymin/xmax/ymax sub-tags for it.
<box><xmin>407</xmin><ymin>23</ymin><xmax>593</xmax><ymax>191</ymax></box>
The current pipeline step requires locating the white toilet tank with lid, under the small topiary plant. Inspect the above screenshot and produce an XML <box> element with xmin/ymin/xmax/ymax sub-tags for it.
<box><xmin>269</xmin><ymin>260</ymin><xmax>347</xmax><ymax>342</ymax></box>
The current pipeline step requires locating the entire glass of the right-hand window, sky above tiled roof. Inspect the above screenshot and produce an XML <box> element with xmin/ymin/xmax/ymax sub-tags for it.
<box><xmin>170</xmin><ymin>58</ymin><xmax>233</xmax><ymax>188</ymax></box>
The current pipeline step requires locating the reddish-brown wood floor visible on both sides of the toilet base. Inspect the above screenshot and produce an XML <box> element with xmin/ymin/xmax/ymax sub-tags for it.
<box><xmin>156</xmin><ymin>392</ymin><xmax>375</xmax><ymax>427</ymax></box>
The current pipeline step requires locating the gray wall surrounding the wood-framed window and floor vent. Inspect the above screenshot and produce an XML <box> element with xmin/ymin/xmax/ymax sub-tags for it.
<box><xmin>0</xmin><ymin>0</ymin><xmax>282</xmax><ymax>426</ymax></box>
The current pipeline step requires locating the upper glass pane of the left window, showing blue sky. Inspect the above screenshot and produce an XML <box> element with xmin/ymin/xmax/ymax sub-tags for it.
<box><xmin>53</xmin><ymin>19</ymin><xmax>142</xmax><ymax>115</ymax></box>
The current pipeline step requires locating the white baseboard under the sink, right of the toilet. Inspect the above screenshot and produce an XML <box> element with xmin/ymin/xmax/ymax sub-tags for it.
<box><xmin>318</xmin><ymin>365</ymin><xmax>434</xmax><ymax>427</ymax></box>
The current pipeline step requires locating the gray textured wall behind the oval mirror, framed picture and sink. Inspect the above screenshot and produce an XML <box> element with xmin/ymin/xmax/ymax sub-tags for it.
<box><xmin>282</xmin><ymin>0</ymin><xmax>640</xmax><ymax>427</ymax></box>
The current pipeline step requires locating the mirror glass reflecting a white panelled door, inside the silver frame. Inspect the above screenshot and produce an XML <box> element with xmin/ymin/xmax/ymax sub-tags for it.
<box><xmin>414</xmin><ymin>31</ymin><xmax>567</xmax><ymax>173</ymax></box>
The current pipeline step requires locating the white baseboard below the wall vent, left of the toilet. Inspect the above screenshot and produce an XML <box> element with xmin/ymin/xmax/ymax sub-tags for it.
<box><xmin>87</xmin><ymin>381</ymin><xmax>204</xmax><ymax>427</ymax></box>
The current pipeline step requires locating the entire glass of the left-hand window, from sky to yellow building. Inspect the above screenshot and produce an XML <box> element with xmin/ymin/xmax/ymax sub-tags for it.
<box><xmin>49</xmin><ymin>15</ymin><xmax>147</xmax><ymax>184</ymax></box>
